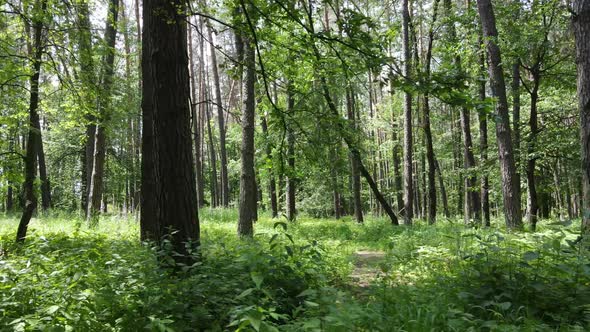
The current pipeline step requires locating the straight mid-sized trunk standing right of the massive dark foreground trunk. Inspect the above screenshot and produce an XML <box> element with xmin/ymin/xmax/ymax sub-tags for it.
<box><xmin>238</xmin><ymin>33</ymin><xmax>256</xmax><ymax>237</ymax></box>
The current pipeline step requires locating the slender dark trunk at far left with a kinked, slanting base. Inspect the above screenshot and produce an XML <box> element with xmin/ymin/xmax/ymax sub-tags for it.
<box><xmin>16</xmin><ymin>0</ymin><xmax>47</xmax><ymax>242</ymax></box>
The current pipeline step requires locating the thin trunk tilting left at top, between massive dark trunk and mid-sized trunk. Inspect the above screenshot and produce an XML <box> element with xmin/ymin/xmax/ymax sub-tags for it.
<box><xmin>205</xmin><ymin>21</ymin><xmax>229</xmax><ymax>207</ymax></box>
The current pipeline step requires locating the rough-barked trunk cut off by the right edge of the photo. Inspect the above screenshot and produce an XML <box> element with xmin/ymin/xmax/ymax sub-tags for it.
<box><xmin>572</xmin><ymin>0</ymin><xmax>590</xmax><ymax>235</ymax></box>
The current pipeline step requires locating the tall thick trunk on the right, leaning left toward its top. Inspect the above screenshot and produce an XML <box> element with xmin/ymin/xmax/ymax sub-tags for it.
<box><xmin>477</xmin><ymin>0</ymin><xmax>522</xmax><ymax>228</ymax></box>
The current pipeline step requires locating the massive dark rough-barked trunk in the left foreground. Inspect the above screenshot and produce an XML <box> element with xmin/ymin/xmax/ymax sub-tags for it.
<box><xmin>141</xmin><ymin>0</ymin><xmax>199</xmax><ymax>252</ymax></box>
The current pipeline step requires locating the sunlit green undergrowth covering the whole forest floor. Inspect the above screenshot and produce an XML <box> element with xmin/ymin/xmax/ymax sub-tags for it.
<box><xmin>0</xmin><ymin>210</ymin><xmax>590</xmax><ymax>331</ymax></box>
